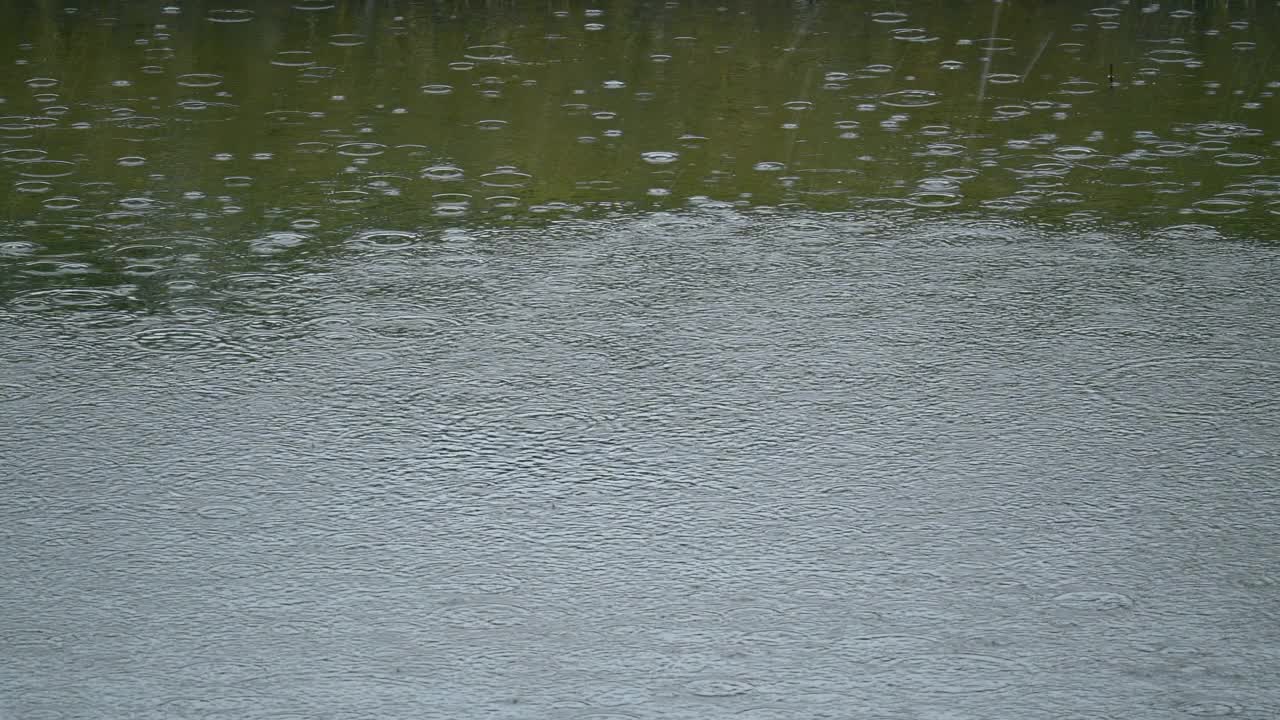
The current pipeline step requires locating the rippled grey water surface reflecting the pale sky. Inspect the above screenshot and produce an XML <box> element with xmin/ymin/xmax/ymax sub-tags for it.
<box><xmin>0</xmin><ymin>210</ymin><xmax>1280</xmax><ymax>720</ymax></box>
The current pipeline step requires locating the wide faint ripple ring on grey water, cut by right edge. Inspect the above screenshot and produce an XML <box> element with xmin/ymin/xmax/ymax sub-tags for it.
<box><xmin>1092</xmin><ymin>356</ymin><xmax>1280</xmax><ymax>416</ymax></box>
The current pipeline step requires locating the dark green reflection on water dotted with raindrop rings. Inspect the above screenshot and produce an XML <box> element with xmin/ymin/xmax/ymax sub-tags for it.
<box><xmin>0</xmin><ymin>0</ymin><xmax>1280</xmax><ymax>304</ymax></box>
